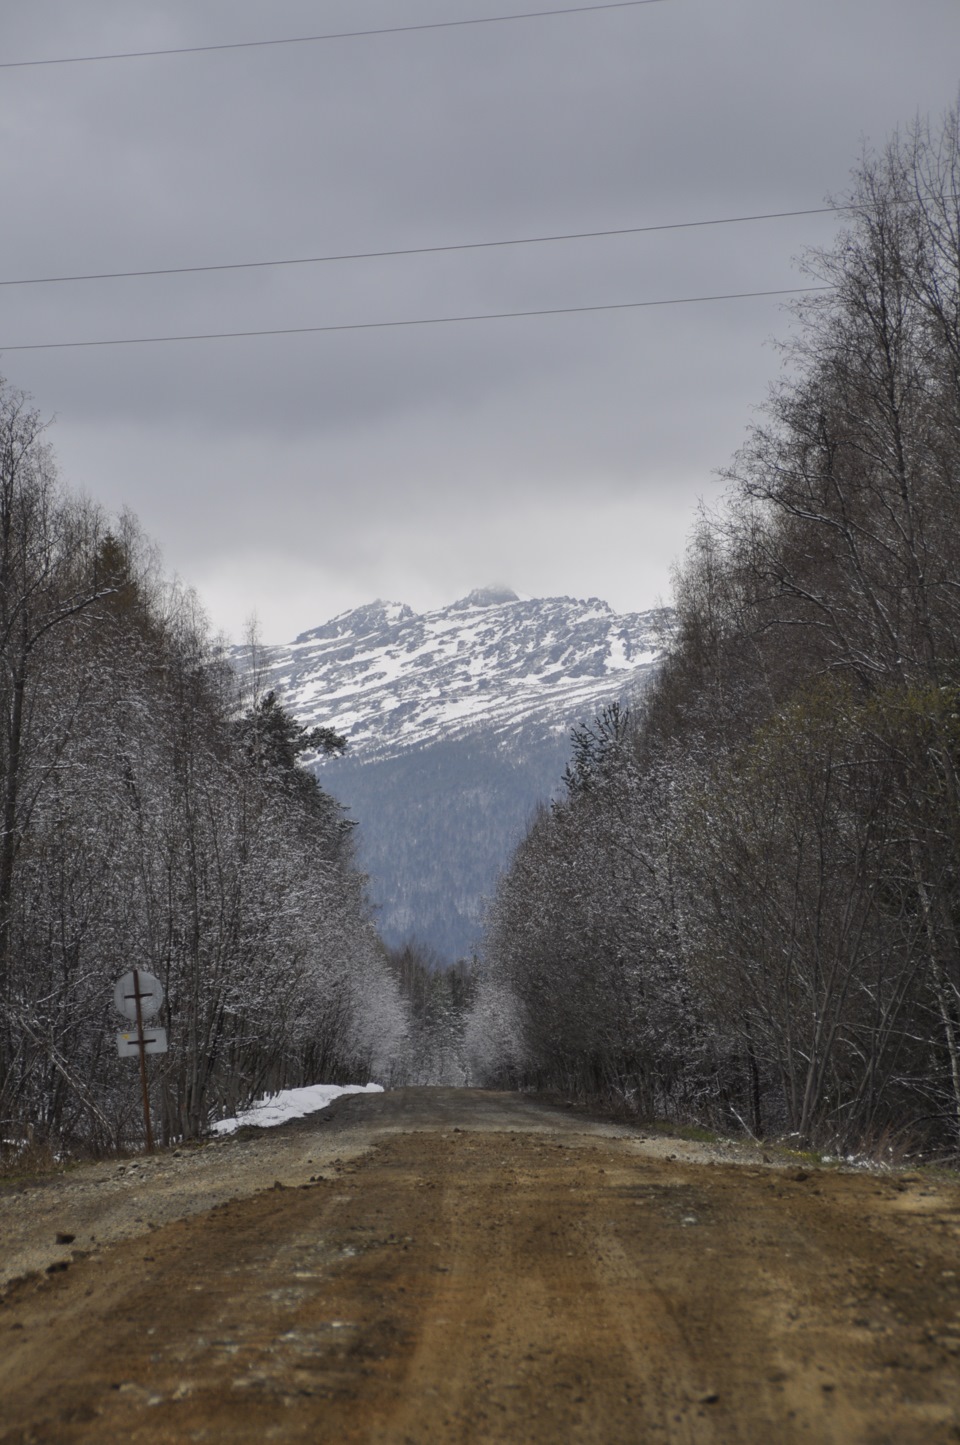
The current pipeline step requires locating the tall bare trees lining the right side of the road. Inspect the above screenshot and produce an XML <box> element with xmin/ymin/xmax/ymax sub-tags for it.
<box><xmin>474</xmin><ymin>111</ymin><xmax>960</xmax><ymax>1147</ymax></box>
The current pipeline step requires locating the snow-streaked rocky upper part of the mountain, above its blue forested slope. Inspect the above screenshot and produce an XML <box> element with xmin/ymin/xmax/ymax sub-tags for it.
<box><xmin>239</xmin><ymin>588</ymin><xmax>671</xmax><ymax>762</ymax></box>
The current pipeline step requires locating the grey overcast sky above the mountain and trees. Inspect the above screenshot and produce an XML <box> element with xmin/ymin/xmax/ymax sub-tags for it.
<box><xmin>0</xmin><ymin>0</ymin><xmax>960</xmax><ymax>642</ymax></box>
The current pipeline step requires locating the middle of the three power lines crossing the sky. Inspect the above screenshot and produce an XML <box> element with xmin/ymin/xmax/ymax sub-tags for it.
<box><xmin>0</xmin><ymin>205</ymin><xmax>856</xmax><ymax>286</ymax></box>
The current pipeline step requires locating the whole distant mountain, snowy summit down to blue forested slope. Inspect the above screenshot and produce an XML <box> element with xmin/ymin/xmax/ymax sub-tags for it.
<box><xmin>237</xmin><ymin>587</ymin><xmax>672</xmax><ymax>957</ymax></box>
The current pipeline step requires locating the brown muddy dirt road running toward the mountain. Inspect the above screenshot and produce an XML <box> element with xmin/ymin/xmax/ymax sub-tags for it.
<box><xmin>0</xmin><ymin>1090</ymin><xmax>960</xmax><ymax>1445</ymax></box>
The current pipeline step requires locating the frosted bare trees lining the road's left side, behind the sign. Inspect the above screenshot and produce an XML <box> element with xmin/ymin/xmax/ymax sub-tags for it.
<box><xmin>0</xmin><ymin>383</ymin><xmax>408</xmax><ymax>1149</ymax></box>
